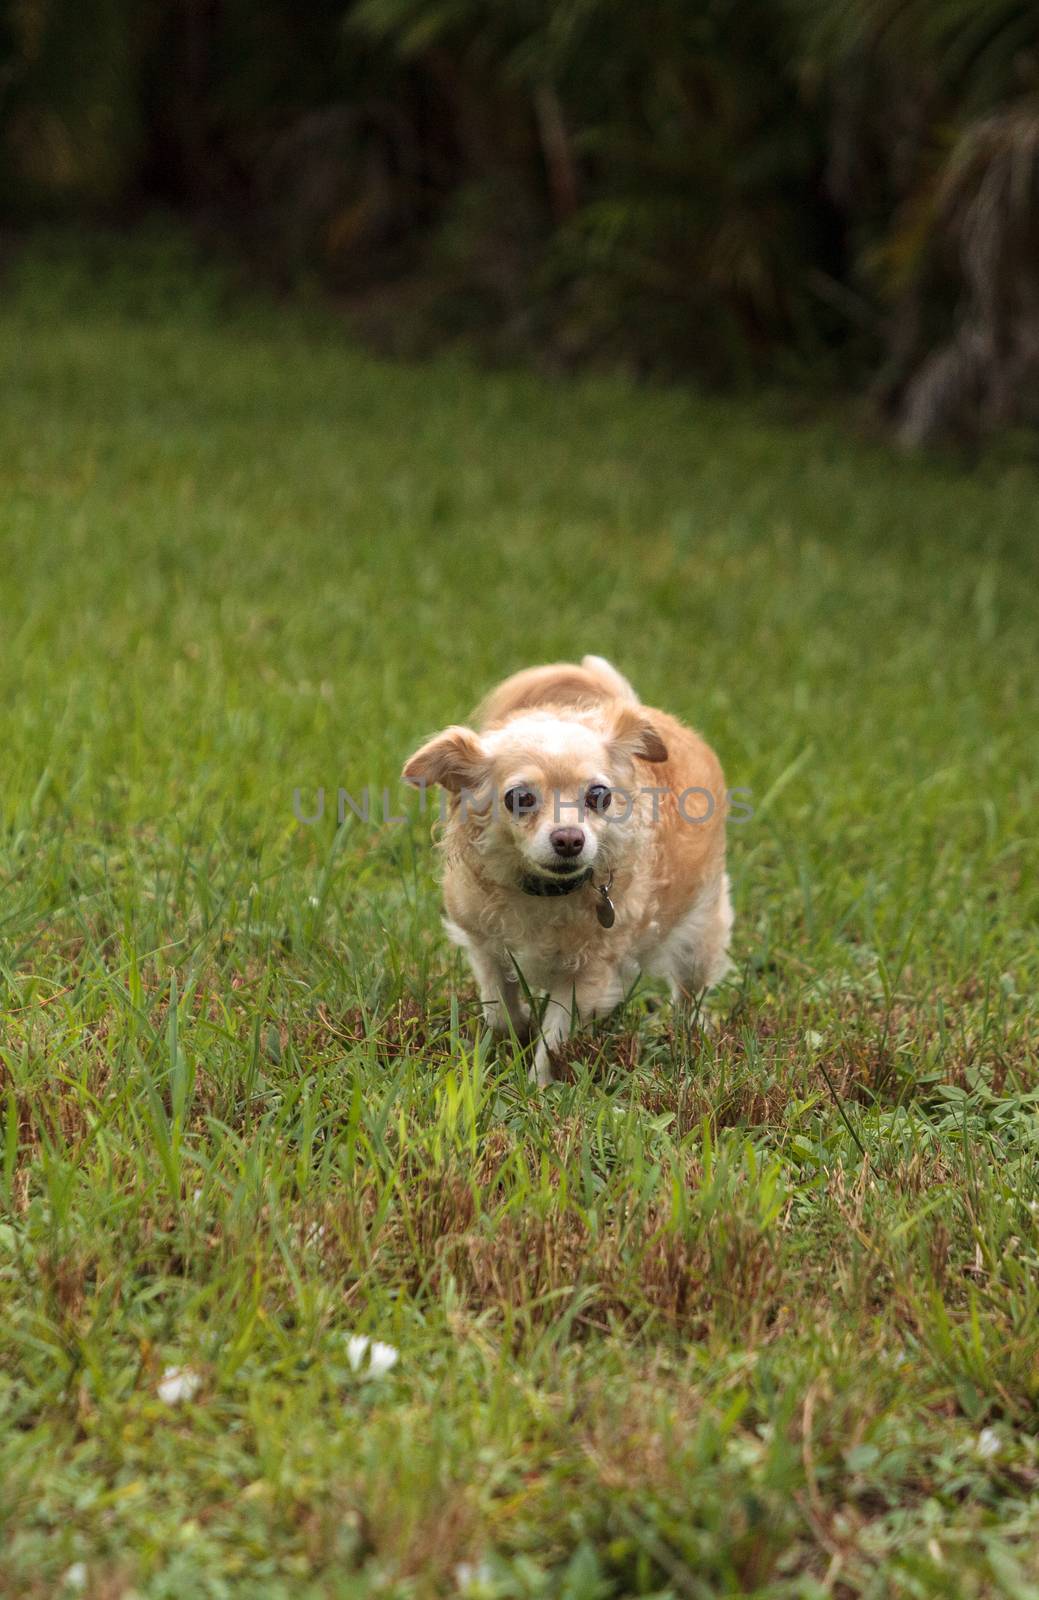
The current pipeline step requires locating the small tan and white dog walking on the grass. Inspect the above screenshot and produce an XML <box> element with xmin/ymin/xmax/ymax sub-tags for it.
<box><xmin>403</xmin><ymin>656</ymin><xmax>732</xmax><ymax>1085</ymax></box>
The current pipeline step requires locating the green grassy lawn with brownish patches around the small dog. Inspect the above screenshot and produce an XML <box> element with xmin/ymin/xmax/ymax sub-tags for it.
<box><xmin>0</xmin><ymin>256</ymin><xmax>1039</xmax><ymax>1600</ymax></box>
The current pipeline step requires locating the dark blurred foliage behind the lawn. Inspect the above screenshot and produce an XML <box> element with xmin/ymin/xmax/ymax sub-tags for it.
<box><xmin>0</xmin><ymin>0</ymin><xmax>1039</xmax><ymax>443</ymax></box>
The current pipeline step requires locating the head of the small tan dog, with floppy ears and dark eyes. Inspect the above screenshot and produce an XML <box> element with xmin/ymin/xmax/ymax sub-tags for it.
<box><xmin>403</xmin><ymin>704</ymin><xmax>668</xmax><ymax>885</ymax></box>
